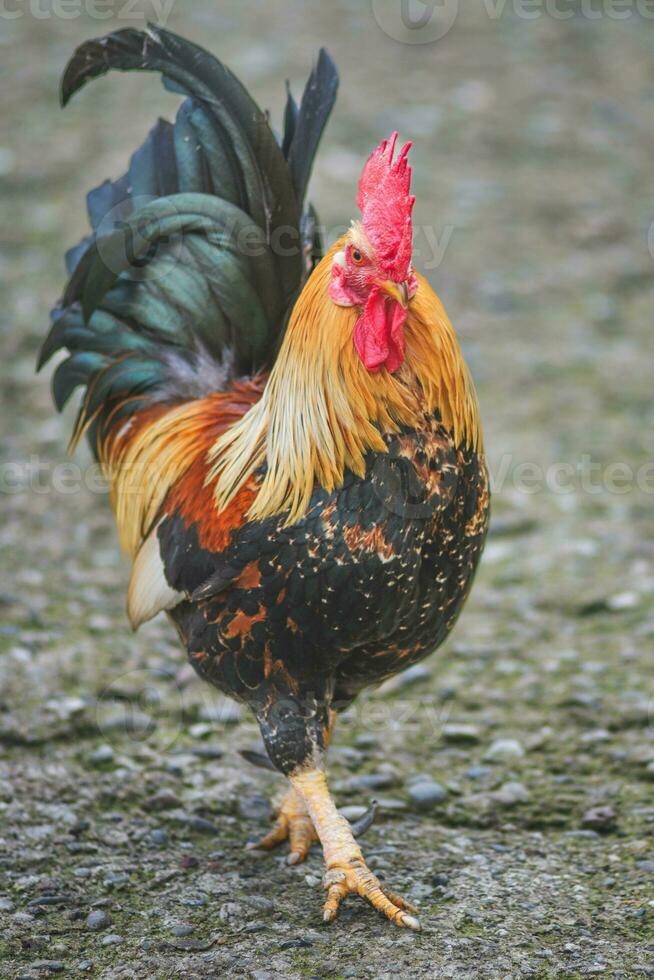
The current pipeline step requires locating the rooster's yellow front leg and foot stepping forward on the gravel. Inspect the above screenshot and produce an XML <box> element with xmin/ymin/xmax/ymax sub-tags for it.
<box><xmin>289</xmin><ymin>769</ymin><xmax>420</xmax><ymax>930</ymax></box>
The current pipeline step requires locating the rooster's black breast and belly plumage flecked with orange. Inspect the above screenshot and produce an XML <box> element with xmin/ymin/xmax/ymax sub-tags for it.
<box><xmin>164</xmin><ymin>416</ymin><xmax>489</xmax><ymax>773</ymax></box>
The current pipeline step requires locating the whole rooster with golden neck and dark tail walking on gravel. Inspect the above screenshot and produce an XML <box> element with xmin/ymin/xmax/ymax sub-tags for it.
<box><xmin>40</xmin><ymin>26</ymin><xmax>489</xmax><ymax>929</ymax></box>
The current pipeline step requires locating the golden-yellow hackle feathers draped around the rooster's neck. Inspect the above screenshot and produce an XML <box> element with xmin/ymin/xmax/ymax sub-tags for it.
<box><xmin>208</xmin><ymin>239</ymin><xmax>482</xmax><ymax>523</ymax></box>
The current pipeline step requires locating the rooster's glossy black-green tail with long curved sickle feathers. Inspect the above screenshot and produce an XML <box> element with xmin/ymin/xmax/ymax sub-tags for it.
<box><xmin>39</xmin><ymin>26</ymin><xmax>338</xmax><ymax>452</ymax></box>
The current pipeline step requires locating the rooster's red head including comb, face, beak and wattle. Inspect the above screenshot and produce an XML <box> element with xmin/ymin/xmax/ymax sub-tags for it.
<box><xmin>329</xmin><ymin>133</ymin><xmax>418</xmax><ymax>374</ymax></box>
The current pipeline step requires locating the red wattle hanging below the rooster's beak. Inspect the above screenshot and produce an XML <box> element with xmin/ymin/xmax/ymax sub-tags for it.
<box><xmin>354</xmin><ymin>286</ymin><xmax>407</xmax><ymax>374</ymax></box>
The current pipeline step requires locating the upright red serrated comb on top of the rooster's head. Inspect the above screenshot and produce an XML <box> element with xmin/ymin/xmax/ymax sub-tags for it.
<box><xmin>357</xmin><ymin>133</ymin><xmax>415</xmax><ymax>282</ymax></box>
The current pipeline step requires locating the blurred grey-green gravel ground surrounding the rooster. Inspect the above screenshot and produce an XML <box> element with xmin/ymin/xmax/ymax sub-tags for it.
<box><xmin>0</xmin><ymin>0</ymin><xmax>654</xmax><ymax>980</ymax></box>
